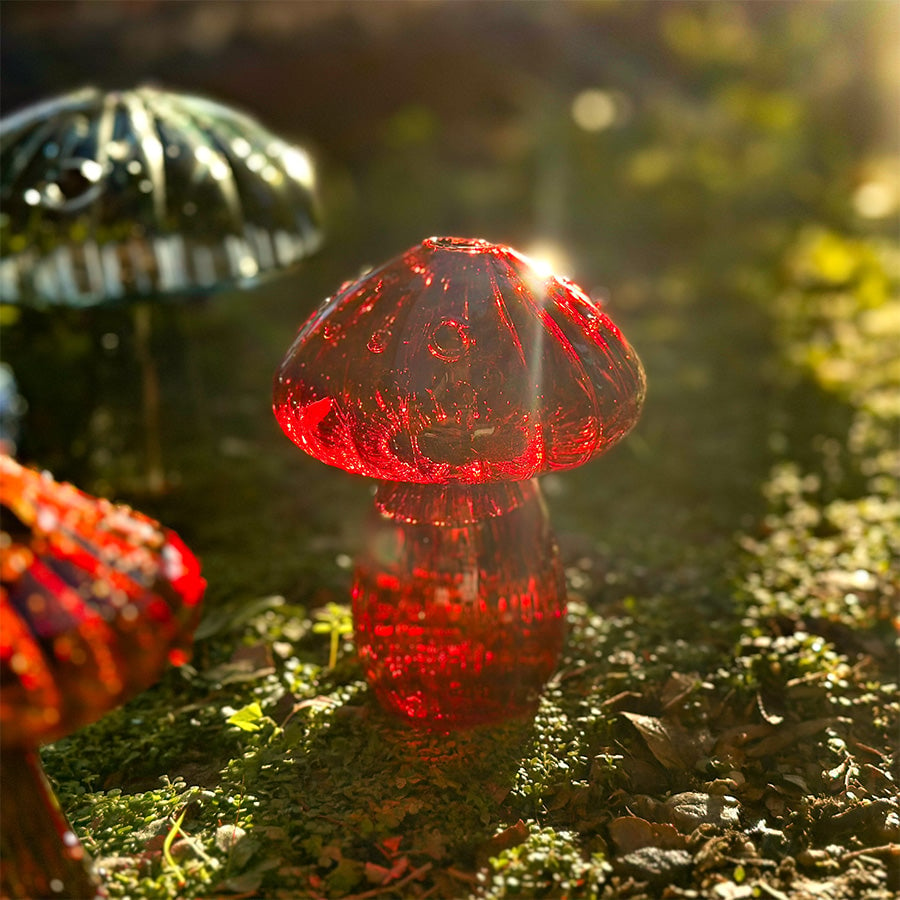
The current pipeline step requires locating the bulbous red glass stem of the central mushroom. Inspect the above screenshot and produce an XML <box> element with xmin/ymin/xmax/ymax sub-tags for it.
<box><xmin>353</xmin><ymin>480</ymin><xmax>566</xmax><ymax>730</ymax></box>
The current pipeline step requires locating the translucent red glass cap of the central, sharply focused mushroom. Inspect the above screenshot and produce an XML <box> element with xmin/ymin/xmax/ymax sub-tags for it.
<box><xmin>274</xmin><ymin>238</ymin><xmax>645</xmax><ymax>484</ymax></box>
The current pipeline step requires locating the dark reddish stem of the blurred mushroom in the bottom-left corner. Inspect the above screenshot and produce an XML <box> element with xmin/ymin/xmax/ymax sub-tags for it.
<box><xmin>0</xmin><ymin>747</ymin><xmax>107</xmax><ymax>900</ymax></box>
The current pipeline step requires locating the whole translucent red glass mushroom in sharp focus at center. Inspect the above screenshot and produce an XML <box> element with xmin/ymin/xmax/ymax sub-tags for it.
<box><xmin>274</xmin><ymin>238</ymin><xmax>645</xmax><ymax>729</ymax></box>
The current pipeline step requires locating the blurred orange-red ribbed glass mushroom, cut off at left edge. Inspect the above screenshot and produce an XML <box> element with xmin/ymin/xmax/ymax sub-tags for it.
<box><xmin>0</xmin><ymin>456</ymin><xmax>206</xmax><ymax>900</ymax></box>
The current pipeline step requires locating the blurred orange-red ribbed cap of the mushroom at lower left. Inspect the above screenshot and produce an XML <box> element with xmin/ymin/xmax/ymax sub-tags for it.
<box><xmin>0</xmin><ymin>456</ymin><xmax>206</xmax><ymax>746</ymax></box>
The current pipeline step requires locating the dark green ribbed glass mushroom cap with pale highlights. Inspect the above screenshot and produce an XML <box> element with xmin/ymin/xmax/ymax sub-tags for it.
<box><xmin>0</xmin><ymin>87</ymin><xmax>321</xmax><ymax>306</ymax></box>
